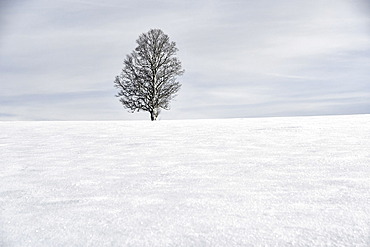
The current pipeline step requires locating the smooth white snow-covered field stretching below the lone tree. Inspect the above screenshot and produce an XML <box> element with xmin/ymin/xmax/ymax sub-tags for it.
<box><xmin>0</xmin><ymin>115</ymin><xmax>370</xmax><ymax>246</ymax></box>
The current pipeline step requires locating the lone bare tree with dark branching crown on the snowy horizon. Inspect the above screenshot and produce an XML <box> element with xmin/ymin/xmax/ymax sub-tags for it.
<box><xmin>114</xmin><ymin>29</ymin><xmax>184</xmax><ymax>121</ymax></box>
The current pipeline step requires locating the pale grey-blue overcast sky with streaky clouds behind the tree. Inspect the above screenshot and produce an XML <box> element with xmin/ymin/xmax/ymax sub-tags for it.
<box><xmin>0</xmin><ymin>0</ymin><xmax>370</xmax><ymax>120</ymax></box>
